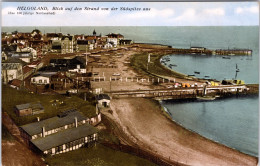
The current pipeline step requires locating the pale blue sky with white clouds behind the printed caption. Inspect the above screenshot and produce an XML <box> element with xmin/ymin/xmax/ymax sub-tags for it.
<box><xmin>1</xmin><ymin>2</ymin><xmax>259</xmax><ymax>26</ymax></box>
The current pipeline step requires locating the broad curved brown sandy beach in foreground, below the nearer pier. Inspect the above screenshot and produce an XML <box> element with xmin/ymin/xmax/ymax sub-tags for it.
<box><xmin>104</xmin><ymin>98</ymin><xmax>257</xmax><ymax>166</ymax></box>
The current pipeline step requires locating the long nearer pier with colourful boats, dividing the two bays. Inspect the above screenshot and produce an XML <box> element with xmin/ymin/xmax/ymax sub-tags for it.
<box><xmin>107</xmin><ymin>84</ymin><xmax>259</xmax><ymax>100</ymax></box>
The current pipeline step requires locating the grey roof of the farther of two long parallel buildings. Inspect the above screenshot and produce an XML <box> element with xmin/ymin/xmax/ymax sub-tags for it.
<box><xmin>21</xmin><ymin>110</ymin><xmax>87</xmax><ymax>136</ymax></box>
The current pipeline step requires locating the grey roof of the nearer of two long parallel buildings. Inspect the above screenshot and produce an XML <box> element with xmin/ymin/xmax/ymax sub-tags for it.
<box><xmin>32</xmin><ymin>124</ymin><xmax>97</xmax><ymax>151</ymax></box>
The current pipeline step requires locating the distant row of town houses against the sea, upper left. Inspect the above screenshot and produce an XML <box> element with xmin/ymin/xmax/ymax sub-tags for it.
<box><xmin>2</xmin><ymin>29</ymin><xmax>132</xmax><ymax>57</ymax></box>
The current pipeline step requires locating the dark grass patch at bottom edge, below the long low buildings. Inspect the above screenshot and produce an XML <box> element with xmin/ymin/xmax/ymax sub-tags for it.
<box><xmin>46</xmin><ymin>144</ymin><xmax>155</xmax><ymax>166</ymax></box>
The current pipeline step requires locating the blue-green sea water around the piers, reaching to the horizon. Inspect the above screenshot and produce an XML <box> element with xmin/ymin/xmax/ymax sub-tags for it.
<box><xmin>2</xmin><ymin>26</ymin><xmax>259</xmax><ymax>156</ymax></box>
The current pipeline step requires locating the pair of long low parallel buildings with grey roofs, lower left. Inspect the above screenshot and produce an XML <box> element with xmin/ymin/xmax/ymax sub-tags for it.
<box><xmin>19</xmin><ymin>110</ymin><xmax>98</xmax><ymax>155</ymax></box>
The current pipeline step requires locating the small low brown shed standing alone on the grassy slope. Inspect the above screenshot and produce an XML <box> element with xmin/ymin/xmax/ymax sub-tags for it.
<box><xmin>15</xmin><ymin>102</ymin><xmax>44</xmax><ymax>116</ymax></box>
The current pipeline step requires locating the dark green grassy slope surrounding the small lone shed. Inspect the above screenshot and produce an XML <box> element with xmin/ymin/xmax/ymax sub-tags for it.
<box><xmin>2</xmin><ymin>85</ymin><xmax>96</xmax><ymax>125</ymax></box>
